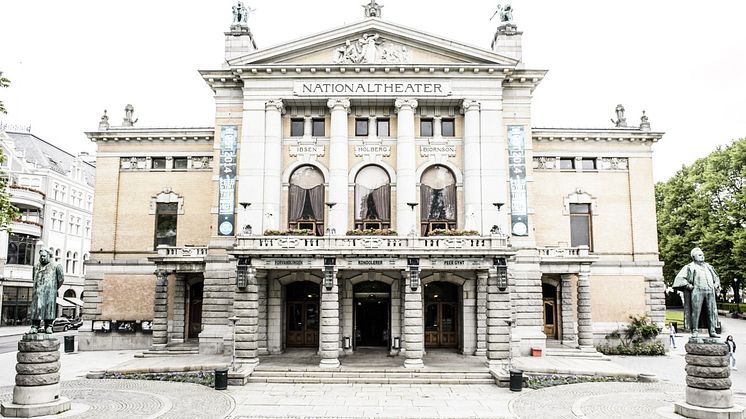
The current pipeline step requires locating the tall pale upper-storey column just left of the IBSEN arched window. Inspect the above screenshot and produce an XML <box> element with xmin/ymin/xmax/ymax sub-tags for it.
<box><xmin>264</xmin><ymin>99</ymin><xmax>284</xmax><ymax>233</ymax></box>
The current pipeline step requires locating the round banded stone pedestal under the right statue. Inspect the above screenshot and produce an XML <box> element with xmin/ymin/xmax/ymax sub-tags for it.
<box><xmin>674</xmin><ymin>337</ymin><xmax>746</xmax><ymax>419</ymax></box>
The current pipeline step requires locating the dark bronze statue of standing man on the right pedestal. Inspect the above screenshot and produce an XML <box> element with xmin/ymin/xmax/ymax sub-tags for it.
<box><xmin>673</xmin><ymin>247</ymin><xmax>720</xmax><ymax>338</ymax></box>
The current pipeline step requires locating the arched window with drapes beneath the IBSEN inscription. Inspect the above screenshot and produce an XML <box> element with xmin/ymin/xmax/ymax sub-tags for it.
<box><xmin>288</xmin><ymin>166</ymin><xmax>324</xmax><ymax>236</ymax></box>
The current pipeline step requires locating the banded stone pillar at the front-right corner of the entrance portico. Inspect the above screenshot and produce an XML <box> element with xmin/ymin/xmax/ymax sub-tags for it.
<box><xmin>487</xmin><ymin>269</ymin><xmax>511</xmax><ymax>366</ymax></box>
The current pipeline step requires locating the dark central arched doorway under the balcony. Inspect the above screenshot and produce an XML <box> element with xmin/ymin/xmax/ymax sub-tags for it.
<box><xmin>353</xmin><ymin>281</ymin><xmax>391</xmax><ymax>348</ymax></box>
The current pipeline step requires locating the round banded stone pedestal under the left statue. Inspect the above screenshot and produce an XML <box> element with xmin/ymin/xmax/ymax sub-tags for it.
<box><xmin>0</xmin><ymin>333</ymin><xmax>70</xmax><ymax>418</ymax></box>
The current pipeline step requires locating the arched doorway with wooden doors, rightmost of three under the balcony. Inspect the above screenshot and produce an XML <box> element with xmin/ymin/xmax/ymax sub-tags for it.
<box><xmin>425</xmin><ymin>282</ymin><xmax>460</xmax><ymax>348</ymax></box>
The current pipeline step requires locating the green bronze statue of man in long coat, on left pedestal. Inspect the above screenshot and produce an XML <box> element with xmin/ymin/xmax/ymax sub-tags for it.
<box><xmin>29</xmin><ymin>248</ymin><xmax>65</xmax><ymax>333</ymax></box>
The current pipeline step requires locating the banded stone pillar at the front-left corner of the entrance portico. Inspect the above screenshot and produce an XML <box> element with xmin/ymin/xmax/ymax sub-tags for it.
<box><xmin>233</xmin><ymin>267</ymin><xmax>267</xmax><ymax>365</ymax></box>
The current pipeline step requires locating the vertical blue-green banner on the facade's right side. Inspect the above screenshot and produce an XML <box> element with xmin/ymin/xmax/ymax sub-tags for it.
<box><xmin>508</xmin><ymin>125</ymin><xmax>528</xmax><ymax>236</ymax></box>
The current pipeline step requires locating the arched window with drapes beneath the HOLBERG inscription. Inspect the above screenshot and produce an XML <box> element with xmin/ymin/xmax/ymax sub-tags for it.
<box><xmin>355</xmin><ymin>165</ymin><xmax>391</xmax><ymax>230</ymax></box>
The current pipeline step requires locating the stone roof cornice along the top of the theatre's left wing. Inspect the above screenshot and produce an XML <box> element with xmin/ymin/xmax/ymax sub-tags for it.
<box><xmin>85</xmin><ymin>127</ymin><xmax>215</xmax><ymax>143</ymax></box>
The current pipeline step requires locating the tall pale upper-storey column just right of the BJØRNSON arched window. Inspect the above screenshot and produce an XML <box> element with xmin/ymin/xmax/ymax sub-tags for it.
<box><xmin>461</xmin><ymin>100</ymin><xmax>482</xmax><ymax>234</ymax></box>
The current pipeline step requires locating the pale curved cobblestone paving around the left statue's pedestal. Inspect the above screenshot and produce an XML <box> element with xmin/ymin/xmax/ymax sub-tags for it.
<box><xmin>0</xmin><ymin>380</ymin><xmax>234</xmax><ymax>418</ymax></box>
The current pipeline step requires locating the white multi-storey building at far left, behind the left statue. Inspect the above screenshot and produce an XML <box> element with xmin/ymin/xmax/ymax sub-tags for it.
<box><xmin>0</xmin><ymin>127</ymin><xmax>95</xmax><ymax>326</ymax></box>
